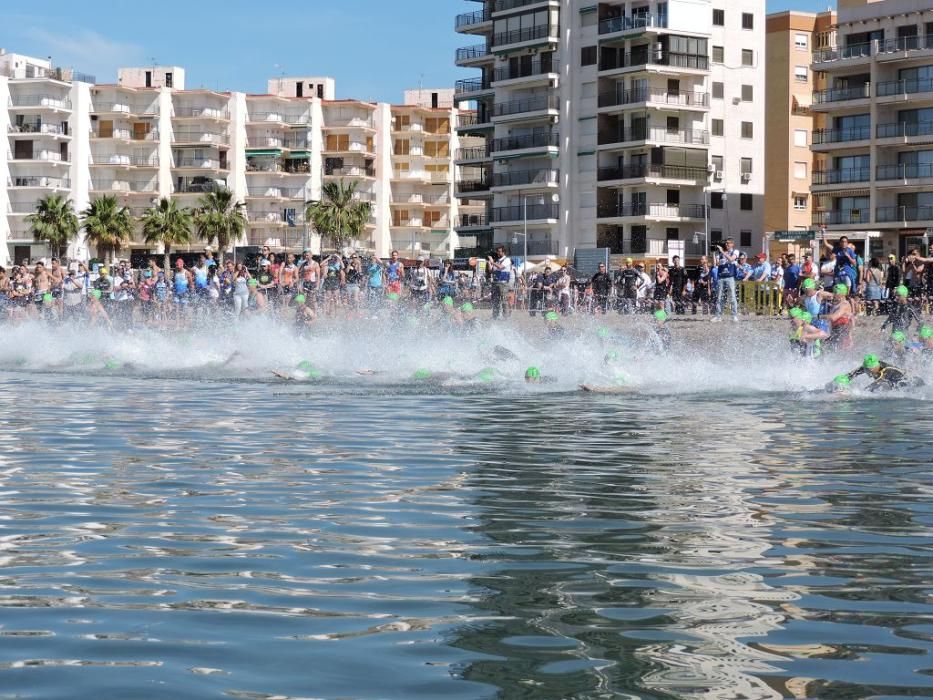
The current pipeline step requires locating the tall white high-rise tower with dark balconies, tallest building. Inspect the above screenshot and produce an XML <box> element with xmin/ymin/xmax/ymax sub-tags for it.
<box><xmin>456</xmin><ymin>0</ymin><xmax>765</xmax><ymax>260</ymax></box>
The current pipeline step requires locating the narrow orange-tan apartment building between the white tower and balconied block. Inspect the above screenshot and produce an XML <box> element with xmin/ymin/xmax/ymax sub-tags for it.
<box><xmin>764</xmin><ymin>10</ymin><xmax>836</xmax><ymax>255</ymax></box>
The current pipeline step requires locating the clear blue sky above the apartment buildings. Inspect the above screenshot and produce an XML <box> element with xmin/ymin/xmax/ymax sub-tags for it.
<box><xmin>0</xmin><ymin>0</ymin><xmax>827</xmax><ymax>102</ymax></box>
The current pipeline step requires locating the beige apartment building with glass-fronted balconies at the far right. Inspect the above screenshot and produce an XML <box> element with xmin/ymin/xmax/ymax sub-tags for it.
<box><xmin>811</xmin><ymin>0</ymin><xmax>933</xmax><ymax>258</ymax></box>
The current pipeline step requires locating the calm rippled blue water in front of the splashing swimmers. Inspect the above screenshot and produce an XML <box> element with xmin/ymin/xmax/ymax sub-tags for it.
<box><xmin>0</xmin><ymin>371</ymin><xmax>933</xmax><ymax>699</ymax></box>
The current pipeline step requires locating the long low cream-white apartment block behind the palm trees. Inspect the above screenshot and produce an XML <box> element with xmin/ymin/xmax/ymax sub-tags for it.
<box><xmin>0</xmin><ymin>54</ymin><xmax>469</xmax><ymax>264</ymax></box>
